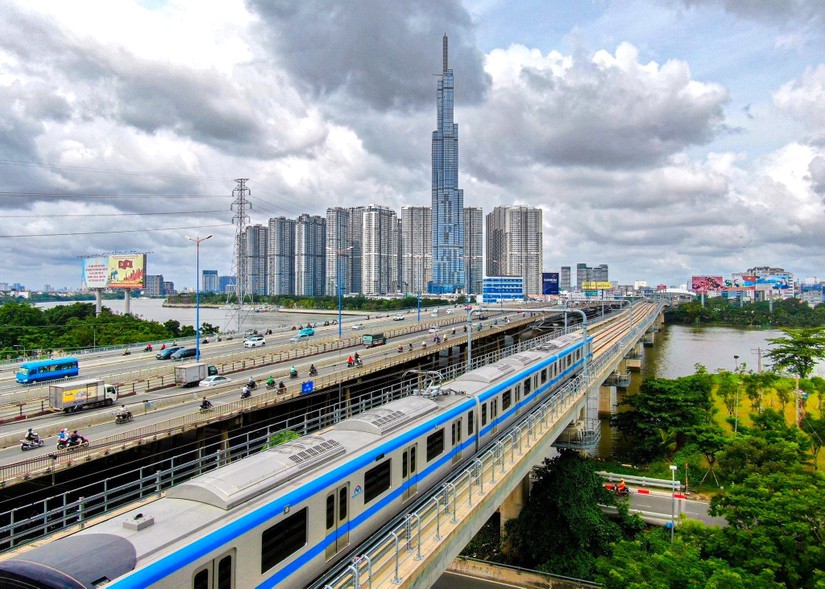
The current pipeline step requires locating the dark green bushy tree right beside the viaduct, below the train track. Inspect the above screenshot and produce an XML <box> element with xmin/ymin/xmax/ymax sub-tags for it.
<box><xmin>498</xmin><ymin>451</ymin><xmax>643</xmax><ymax>578</ymax></box>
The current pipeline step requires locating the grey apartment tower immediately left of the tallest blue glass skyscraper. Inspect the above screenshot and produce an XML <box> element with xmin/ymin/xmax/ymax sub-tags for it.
<box><xmin>399</xmin><ymin>207</ymin><xmax>433</xmax><ymax>294</ymax></box>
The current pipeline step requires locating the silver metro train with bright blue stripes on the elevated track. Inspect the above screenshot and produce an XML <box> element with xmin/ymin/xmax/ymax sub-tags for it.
<box><xmin>0</xmin><ymin>334</ymin><xmax>592</xmax><ymax>589</ymax></box>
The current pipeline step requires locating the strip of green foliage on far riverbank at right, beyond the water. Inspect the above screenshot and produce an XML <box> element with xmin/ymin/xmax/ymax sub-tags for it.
<box><xmin>665</xmin><ymin>297</ymin><xmax>825</xmax><ymax>327</ymax></box>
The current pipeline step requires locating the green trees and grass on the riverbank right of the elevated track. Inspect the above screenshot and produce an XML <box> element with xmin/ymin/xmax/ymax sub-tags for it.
<box><xmin>464</xmin><ymin>329</ymin><xmax>825</xmax><ymax>589</ymax></box>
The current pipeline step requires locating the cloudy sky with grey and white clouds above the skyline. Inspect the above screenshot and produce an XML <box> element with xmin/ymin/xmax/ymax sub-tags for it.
<box><xmin>0</xmin><ymin>0</ymin><xmax>825</xmax><ymax>289</ymax></box>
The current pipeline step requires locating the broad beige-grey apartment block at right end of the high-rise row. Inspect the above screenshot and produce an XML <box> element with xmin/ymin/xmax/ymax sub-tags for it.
<box><xmin>487</xmin><ymin>207</ymin><xmax>544</xmax><ymax>296</ymax></box>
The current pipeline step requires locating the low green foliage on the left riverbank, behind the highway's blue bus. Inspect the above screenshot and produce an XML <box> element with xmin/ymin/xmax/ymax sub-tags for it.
<box><xmin>0</xmin><ymin>302</ymin><xmax>195</xmax><ymax>358</ymax></box>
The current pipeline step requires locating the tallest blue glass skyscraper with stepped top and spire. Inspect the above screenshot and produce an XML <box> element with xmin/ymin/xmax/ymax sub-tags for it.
<box><xmin>428</xmin><ymin>35</ymin><xmax>466</xmax><ymax>294</ymax></box>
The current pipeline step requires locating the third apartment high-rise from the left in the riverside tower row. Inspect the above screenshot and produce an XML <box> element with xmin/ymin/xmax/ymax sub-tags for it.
<box><xmin>295</xmin><ymin>214</ymin><xmax>327</xmax><ymax>297</ymax></box>
